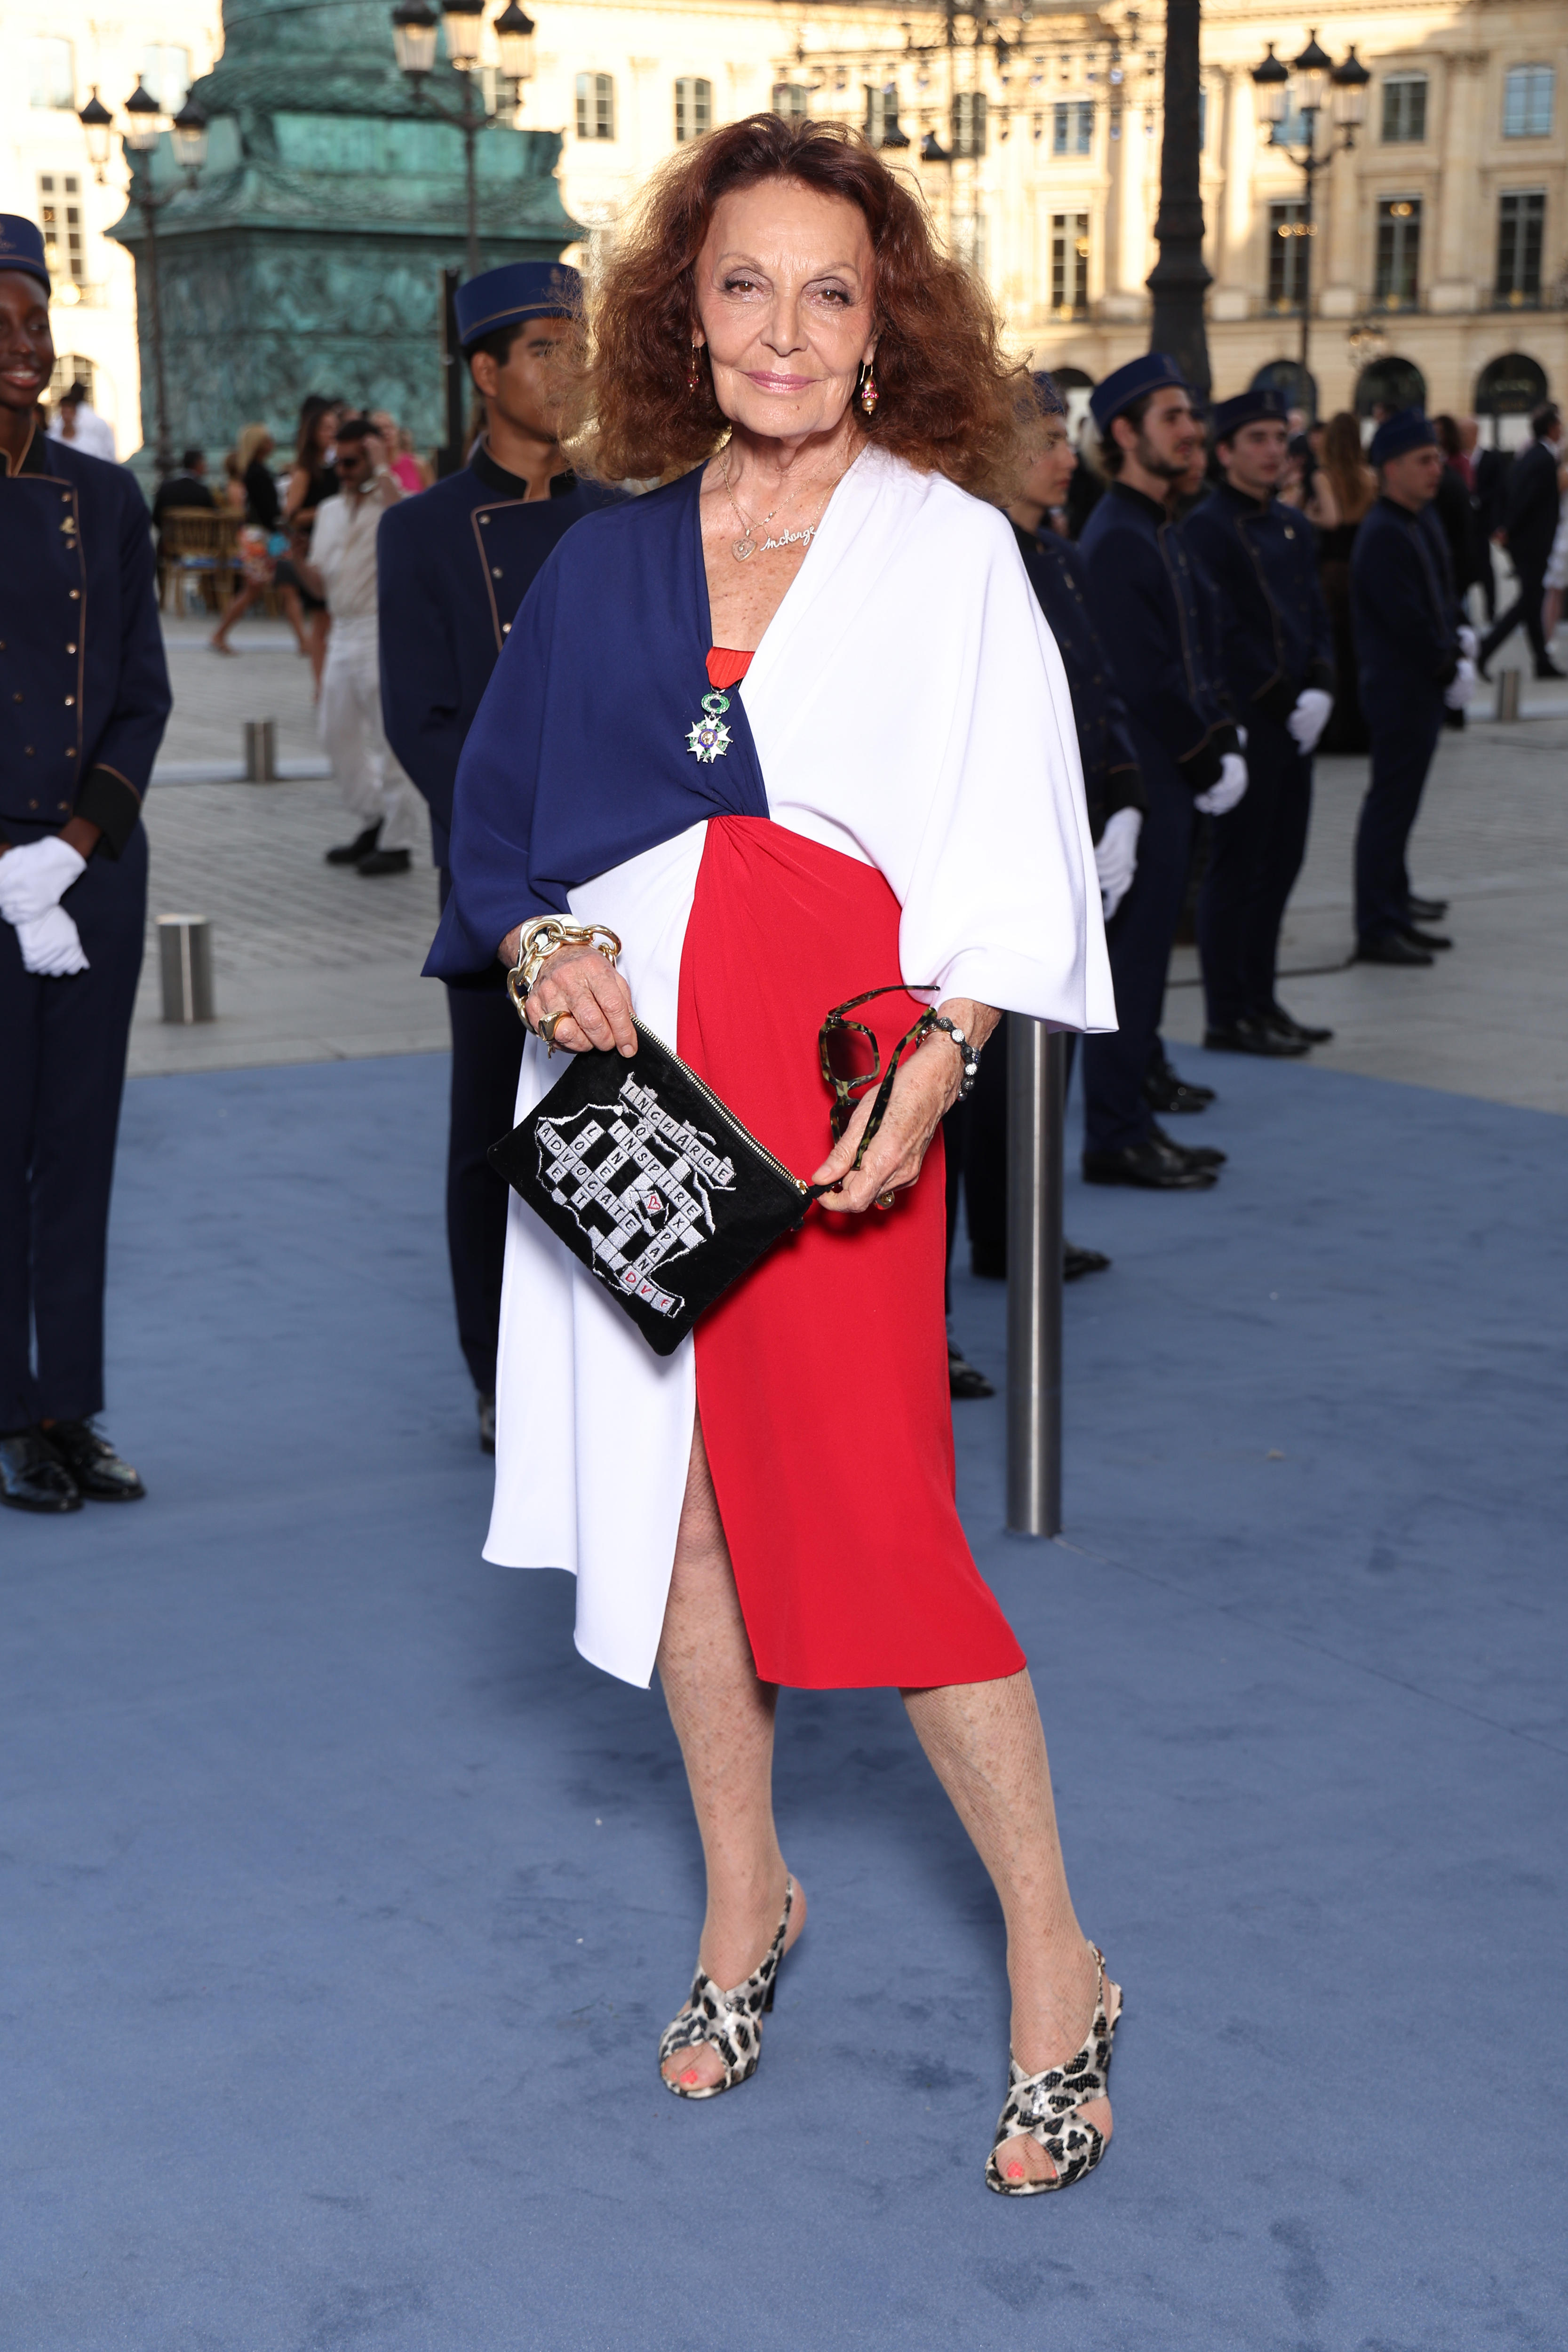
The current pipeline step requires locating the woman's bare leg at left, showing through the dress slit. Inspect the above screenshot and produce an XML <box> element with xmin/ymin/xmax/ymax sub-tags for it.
<box><xmin>658</xmin><ymin>1425</ymin><xmax>806</xmax><ymax>2086</ymax></box>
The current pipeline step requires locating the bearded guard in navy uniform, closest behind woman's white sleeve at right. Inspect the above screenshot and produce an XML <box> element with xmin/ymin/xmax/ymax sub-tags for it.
<box><xmin>1082</xmin><ymin>350</ymin><xmax>1246</xmax><ymax>1192</ymax></box>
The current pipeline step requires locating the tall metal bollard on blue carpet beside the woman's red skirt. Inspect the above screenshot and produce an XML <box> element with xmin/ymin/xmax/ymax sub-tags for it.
<box><xmin>1006</xmin><ymin>1014</ymin><xmax>1067</xmax><ymax>1536</ymax></box>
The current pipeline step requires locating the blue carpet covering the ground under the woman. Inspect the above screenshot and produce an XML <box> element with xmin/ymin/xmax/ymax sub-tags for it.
<box><xmin>0</xmin><ymin>1056</ymin><xmax>1568</xmax><ymax>2352</ymax></box>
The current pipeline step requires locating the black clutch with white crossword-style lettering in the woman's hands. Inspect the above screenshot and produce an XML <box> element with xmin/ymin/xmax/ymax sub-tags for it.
<box><xmin>489</xmin><ymin>1021</ymin><xmax>816</xmax><ymax>1355</ymax></box>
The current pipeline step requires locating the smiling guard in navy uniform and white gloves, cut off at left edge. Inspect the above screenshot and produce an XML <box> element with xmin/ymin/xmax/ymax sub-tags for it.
<box><xmin>0</xmin><ymin>214</ymin><xmax>169</xmax><ymax>1512</ymax></box>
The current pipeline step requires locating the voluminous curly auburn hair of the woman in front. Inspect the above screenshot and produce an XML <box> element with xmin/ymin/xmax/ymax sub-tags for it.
<box><xmin>562</xmin><ymin>115</ymin><xmax>1035</xmax><ymax>499</ymax></box>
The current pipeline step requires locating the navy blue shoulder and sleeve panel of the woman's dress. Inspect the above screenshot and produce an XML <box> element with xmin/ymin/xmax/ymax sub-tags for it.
<box><xmin>425</xmin><ymin>468</ymin><xmax>769</xmax><ymax>978</ymax></box>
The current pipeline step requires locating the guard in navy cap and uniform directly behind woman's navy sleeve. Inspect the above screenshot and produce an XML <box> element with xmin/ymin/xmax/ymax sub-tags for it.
<box><xmin>379</xmin><ymin>261</ymin><xmax>618</xmax><ymax>1454</ymax></box>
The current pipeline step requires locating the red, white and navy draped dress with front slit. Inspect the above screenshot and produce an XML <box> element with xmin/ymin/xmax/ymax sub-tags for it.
<box><xmin>430</xmin><ymin>447</ymin><xmax>1114</xmax><ymax>1689</ymax></box>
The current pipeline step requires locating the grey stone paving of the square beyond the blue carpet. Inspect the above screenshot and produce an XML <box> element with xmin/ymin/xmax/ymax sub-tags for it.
<box><xmin>132</xmin><ymin>623</ymin><xmax>1568</xmax><ymax>1112</ymax></box>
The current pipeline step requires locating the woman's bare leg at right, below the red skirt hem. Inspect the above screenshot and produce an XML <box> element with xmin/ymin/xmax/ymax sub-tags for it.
<box><xmin>903</xmin><ymin>1672</ymin><xmax>1110</xmax><ymax>2180</ymax></box>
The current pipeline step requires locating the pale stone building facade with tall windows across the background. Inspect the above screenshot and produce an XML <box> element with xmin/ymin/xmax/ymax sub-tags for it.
<box><xmin>0</xmin><ymin>0</ymin><xmax>1568</xmax><ymax>447</ymax></box>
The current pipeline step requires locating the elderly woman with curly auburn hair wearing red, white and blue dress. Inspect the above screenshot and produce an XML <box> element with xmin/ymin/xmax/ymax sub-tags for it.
<box><xmin>430</xmin><ymin>115</ymin><xmax>1122</xmax><ymax>2194</ymax></box>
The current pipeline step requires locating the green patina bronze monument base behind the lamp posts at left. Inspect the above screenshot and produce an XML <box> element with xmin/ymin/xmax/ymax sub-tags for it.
<box><xmin>113</xmin><ymin>0</ymin><xmax>581</xmax><ymax>452</ymax></box>
